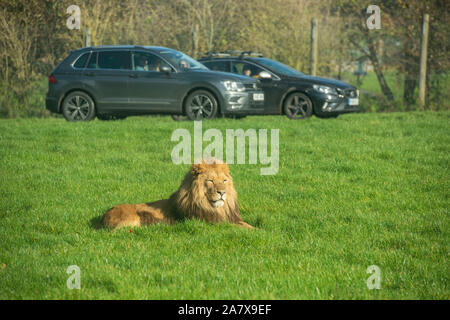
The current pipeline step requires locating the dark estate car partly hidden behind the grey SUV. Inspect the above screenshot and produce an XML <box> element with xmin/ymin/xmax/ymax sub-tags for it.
<box><xmin>199</xmin><ymin>51</ymin><xmax>359</xmax><ymax>119</ymax></box>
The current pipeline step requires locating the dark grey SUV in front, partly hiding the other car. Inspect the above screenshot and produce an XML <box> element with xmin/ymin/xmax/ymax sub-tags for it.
<box><xmin>46</xmin><ymin>46</ymin><xmax>264</xmax><ymax>121</ymax></box>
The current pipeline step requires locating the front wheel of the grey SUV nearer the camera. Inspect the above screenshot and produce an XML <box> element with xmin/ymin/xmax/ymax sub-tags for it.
<box><xmin>184</xmin><ymin>90</ymin><xmax>218</xmax><ymax>120</ymax></box>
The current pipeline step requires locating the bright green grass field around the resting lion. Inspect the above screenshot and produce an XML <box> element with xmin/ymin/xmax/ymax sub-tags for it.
<box><xmin>0</xmin><ymin>112</ymin><xmax>450</xmax><ymax>299</ymax></box>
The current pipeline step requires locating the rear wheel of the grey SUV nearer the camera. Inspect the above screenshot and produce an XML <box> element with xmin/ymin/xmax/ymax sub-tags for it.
<box><xmin>62</xmin><ymin>91</ymin><xmax>95</xmax><ymax>121</ymax></box>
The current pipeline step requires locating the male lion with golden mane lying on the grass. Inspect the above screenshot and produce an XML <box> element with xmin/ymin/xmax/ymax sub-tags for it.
<box><xmin>99</xmin><ymin>159</ymin><xmax>253</xmax><ymax>229</ymax></box>
